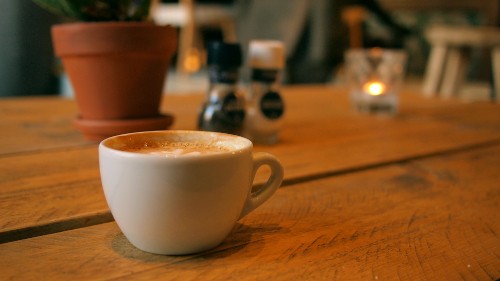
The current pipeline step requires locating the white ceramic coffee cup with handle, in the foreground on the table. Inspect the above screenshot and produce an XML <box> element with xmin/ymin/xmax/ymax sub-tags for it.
<box><xmin>99</xmin><ymin>130</ymin><xmax>283</xmax><ymax>255</ymax></box>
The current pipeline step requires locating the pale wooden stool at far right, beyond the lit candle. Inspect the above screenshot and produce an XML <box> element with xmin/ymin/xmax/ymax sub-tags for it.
<box><xmin>422</xmin><ymin>26</ymin><xmax>500</xmax><ymax>100</ymax></box>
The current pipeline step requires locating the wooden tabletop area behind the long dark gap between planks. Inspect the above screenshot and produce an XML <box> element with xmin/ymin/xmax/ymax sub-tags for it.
<box><xmin>0</xmin><ymin>86</ymin><xmax>500</xmax><ymax>243</ymax></box>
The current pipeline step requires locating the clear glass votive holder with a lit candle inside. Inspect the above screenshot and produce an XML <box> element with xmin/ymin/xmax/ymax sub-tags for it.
<box><xmin>345</xmin><ymin>48</ymin><xmax>407</xmax><ymax>115</ymax></box>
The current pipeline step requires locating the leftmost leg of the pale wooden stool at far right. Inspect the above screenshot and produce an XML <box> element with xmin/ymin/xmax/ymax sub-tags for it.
<box><xmin>422</xmin><ymin>44</ymin><xmax>447</xmax><ymax>97</ymax></box>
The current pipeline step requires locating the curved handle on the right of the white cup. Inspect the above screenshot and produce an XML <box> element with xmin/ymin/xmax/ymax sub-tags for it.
<box><xmin>239</xmin><ymin>152</ymin><xmax>284</xmax><ymax>219</ymax></box>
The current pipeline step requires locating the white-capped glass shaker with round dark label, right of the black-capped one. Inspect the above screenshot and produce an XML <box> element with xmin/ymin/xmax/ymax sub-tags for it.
<box><xmin>243</xmin><ymin>40</ymin><xmax>285</xmax><ymax>144</ymax></box>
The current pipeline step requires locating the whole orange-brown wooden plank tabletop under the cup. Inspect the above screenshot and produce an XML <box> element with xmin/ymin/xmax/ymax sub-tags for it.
<box><xmin>0</xmin><ymin>86</ymin><xmax>500</xmax><ymax>280</ymax></box>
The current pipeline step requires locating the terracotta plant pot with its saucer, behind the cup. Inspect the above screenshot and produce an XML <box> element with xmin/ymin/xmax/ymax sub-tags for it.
<box><xmin>52</xmin><ymin>22</ymin><xmax>177</xmax><ymax>140</ymax></box>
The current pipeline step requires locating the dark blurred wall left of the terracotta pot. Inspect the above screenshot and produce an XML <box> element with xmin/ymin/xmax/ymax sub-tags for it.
<box><xmin>0</xmin><ymin>0</ymin><xmax>58</xmax><ymax>97</ymax></box>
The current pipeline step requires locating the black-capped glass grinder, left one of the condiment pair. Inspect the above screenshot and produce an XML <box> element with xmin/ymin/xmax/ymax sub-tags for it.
<box><xmin>198</xmin><ymin>42</ymin><xmax>245</xmax><ymax>135</ymax></box>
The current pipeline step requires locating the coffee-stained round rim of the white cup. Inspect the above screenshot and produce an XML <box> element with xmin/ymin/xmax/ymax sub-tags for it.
<box><xmin>99</xmin><ymin>130</ymin><xmax>253</xmax><ymax>159</ymax></box>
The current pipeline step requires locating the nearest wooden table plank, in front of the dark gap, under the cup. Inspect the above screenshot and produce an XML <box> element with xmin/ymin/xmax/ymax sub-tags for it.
<box><xmin>0</xmin><ymin>144</ymin><xmax>500</xmax><ymax>280</ymax></box>
